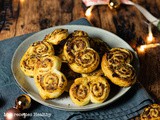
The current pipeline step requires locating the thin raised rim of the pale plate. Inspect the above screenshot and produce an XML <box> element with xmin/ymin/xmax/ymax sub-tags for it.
<box><xmin>11</xmin><ymin>25</ymin><xmax>140</xmax><ymax>111</ymax></box>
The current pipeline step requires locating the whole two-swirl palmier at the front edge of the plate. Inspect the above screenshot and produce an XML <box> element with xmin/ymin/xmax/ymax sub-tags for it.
<box><xmin>69</xmin><ymin>76</ymin><xmax>110</xmax><ymax>106</ymax></box>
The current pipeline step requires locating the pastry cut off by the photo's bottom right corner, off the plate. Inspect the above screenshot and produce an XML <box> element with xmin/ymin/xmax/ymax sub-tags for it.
<box><xmin>140</xmin><ymin>104</ymin><xmax>160</xmax><ymax>120</ymax></box>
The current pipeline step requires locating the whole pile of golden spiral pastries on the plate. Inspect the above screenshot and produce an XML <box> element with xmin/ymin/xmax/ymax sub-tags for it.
<box><xmin>20</xmin><ymin>28</ymin><xmax>136</xmax><ymax>106</ymax></box>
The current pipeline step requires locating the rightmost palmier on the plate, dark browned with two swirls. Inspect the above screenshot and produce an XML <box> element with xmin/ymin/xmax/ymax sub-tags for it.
<box><xmin>101</xmin><ymin>48</ymin><xmax>136</xmax><ymax>87</ymax></box>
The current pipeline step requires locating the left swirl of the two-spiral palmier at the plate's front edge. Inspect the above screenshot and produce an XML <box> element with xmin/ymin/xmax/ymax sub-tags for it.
<box><xmin>69</xmin><ymin>77</ymin><xmax>90</xmax><ymax>106</ymax></box>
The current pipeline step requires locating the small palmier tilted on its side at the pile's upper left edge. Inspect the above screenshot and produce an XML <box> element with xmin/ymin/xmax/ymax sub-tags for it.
<box><xmin>44</xmin><ymin>28</ymin><xmax>69</xmax><ymax>45</ymax></box>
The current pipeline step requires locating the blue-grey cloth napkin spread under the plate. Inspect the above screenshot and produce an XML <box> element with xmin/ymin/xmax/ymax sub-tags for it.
<box><xmin>0</xmin><ymin>18</ymin><xmax>154</xmax><ymax>120</ymax></box>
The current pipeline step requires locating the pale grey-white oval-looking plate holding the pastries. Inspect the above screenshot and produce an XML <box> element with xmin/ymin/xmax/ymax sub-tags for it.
<box><xmin>11</xmin><ymin>25</ymin><xmax>139</xmax><ymax>111</ymax></box>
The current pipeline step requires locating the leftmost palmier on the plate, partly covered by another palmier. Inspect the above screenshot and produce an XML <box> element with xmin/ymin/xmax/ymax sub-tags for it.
<box><xmin>20</xmin><ymin>41</ymin><xmax>54</xmax><ymax>77</ymax></box>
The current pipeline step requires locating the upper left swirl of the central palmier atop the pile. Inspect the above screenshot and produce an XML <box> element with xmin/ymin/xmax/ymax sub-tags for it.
<box><xmin>63</xmin><ymin>36</ymin><xmax>89</xmax><ymax>63</ymax></box>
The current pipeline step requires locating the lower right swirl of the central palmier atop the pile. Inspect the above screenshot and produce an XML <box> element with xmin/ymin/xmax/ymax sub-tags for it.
<box><xmin>69</xmin><ymin>48</ymin><xmax>100</xmax><ymax>73</ymax></box>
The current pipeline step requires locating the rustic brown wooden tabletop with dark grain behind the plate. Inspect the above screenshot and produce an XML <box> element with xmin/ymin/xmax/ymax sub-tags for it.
<box><xmin>0</xmin><ymin>0</ymin><xmax>160</xmax><ymax>111</ymax></box>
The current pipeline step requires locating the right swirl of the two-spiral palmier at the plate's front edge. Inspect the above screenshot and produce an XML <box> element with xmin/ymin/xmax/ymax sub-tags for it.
<box><xmin>88</xmin><ymin>76</ymin><xmax>110</xmax><ymax>103</ymax></box>
